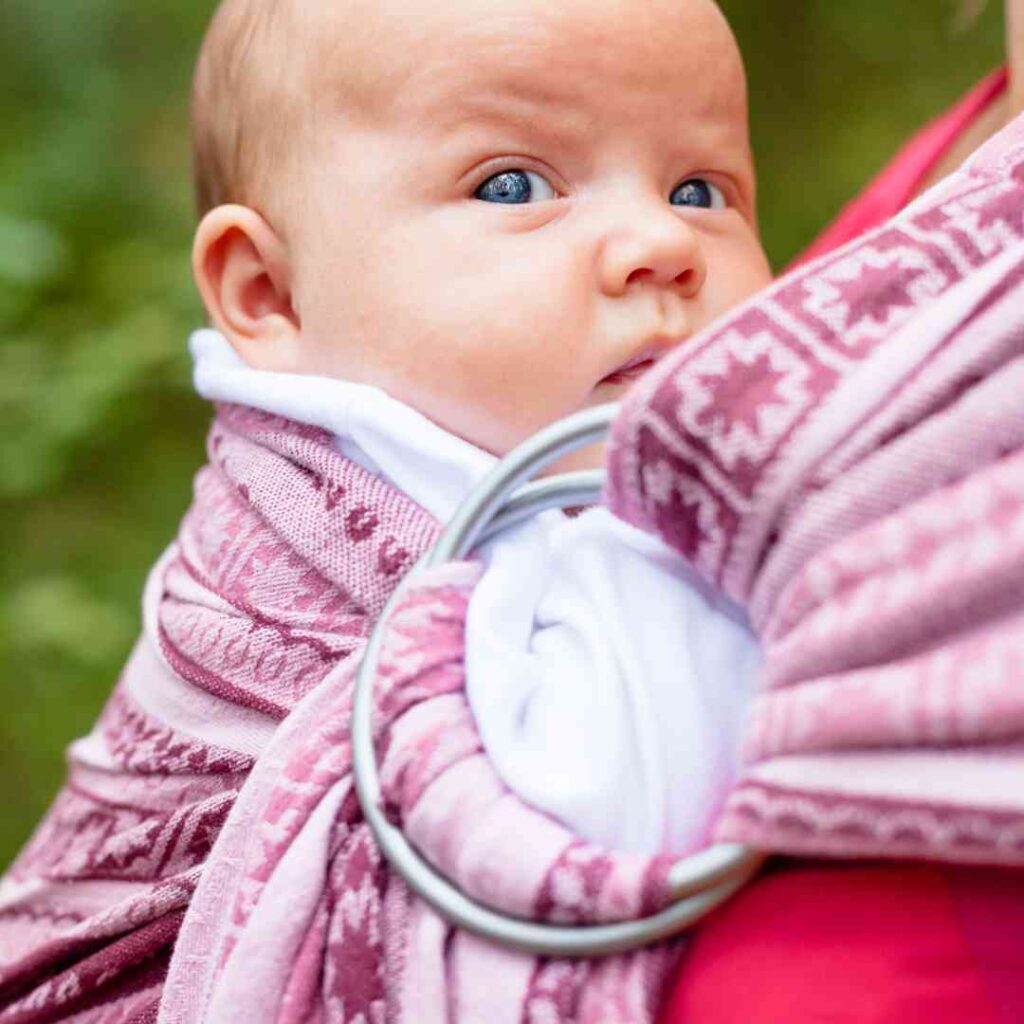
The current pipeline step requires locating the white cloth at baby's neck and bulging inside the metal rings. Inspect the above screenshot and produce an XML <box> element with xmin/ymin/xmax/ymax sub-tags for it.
<box><xmin>191</xmin><ymin>331</ymin><xmax>759</xmax><ymax>853</ymax></box>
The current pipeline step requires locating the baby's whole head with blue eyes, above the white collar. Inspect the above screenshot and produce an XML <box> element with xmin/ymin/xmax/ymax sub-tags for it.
<box><xmin>195</xmin><ymin>0</ymin><xmax>769</xmax><ymax>454</ymax></box>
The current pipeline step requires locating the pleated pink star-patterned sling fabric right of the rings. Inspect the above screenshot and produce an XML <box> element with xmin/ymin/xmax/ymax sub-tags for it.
<box><xmin>608</xmin><ymin>112</ymin><xmax>1024</xmax><ymax>864</ymax></box>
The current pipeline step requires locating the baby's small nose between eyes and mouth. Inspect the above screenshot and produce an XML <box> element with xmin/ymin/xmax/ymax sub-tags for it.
<box><xmin>601</xmin><ymin>202</ymin><xmax>707</xmax><ymax>297</ymax></box>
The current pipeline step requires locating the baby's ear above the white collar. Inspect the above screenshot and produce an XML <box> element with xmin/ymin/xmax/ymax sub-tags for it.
<box><xmin>193</xmin><ymin>205</ymin><xmax>301</xmax><ymax>372</ymax></box>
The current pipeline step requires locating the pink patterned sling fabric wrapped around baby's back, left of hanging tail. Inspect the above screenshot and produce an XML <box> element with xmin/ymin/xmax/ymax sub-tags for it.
<box><xmin>0</xmin><ymin>407</ymin><xmax>436</xmax><ymax>1024</ymax></box>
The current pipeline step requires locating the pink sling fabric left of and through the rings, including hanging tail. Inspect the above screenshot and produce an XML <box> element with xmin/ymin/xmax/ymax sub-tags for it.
<box><xmin>0</xmin><ymin>406</ymin><xmax>674</xmax><ymax>1024</ymax></box>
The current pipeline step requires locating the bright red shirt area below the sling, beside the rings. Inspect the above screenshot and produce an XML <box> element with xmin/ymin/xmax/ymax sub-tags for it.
<box><xmin>660</xmin><ymin>862</ymin><xmax>1024</xmax><ymax>1024</ymax></box>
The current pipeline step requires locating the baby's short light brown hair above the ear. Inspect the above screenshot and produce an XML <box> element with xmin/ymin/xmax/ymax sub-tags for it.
<box><xmin>191</xmin><ymin>0</ymin><xmax>308</xmax><ymax>216</ymax></box>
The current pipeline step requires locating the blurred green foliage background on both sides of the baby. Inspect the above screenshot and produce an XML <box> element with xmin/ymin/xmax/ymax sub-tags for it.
<box><xmin>0</xmin><ymin>0</ymin><xmax>1002</xmax><ymax>865</ymax></box>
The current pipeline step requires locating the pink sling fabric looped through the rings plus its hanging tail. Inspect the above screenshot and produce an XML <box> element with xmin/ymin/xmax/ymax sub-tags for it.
<box><xmin>160</xmin><ymin>563</ymin><xmax>674</xmax><ymax>1024</ymax></box>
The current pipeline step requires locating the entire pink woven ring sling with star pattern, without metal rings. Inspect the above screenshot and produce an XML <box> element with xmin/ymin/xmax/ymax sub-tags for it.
<box><xmin>6</xmin><ymin>114</ymin><xmax>1024</xmax><ymax>1024</ymax></box>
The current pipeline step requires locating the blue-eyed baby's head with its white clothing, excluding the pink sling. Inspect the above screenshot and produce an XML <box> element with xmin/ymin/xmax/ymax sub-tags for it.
<box><xmin>194</xmin><ymin>0</ymin><xmax>769</xmax><ymax>851</ymax></box>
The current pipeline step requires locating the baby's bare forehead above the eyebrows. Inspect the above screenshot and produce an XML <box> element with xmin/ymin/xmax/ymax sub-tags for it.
<box><xmin>321</xmin><ymin>0</ymin><xmax>746</xmax><ymax>157</ymax></box>
